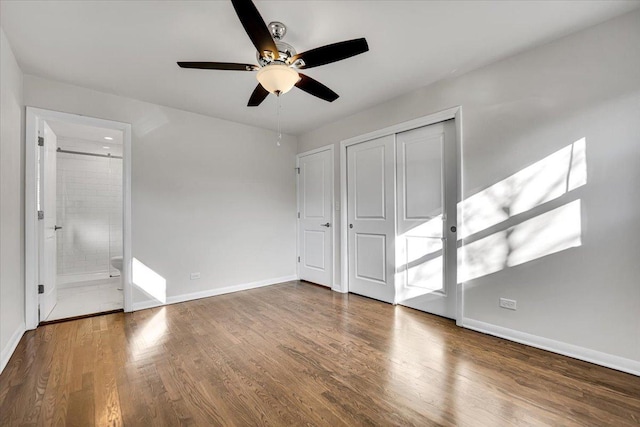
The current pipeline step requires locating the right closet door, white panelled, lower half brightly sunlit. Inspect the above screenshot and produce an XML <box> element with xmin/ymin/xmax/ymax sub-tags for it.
<box><xmin>396</xmin><ymin>120</ymin><xmax>457</xmax><ymax>318</ymax></box>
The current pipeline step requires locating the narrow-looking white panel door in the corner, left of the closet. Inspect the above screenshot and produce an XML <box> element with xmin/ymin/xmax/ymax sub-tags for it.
<box><xmin>298</xmin><ymin>150</ymin><xmax>333</xmax><ymax>287</ymax></box>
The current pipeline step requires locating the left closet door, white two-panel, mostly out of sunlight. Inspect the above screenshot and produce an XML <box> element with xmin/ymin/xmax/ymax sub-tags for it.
<box><xmin>347</xmin><ymin>135</ymin><xmax>395</xmax><ymax>304</ymax></box>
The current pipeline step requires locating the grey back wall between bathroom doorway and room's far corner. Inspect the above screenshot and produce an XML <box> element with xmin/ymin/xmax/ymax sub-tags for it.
<box><xmin>24</xmin><ymin>75</ymin><xmax>296</xmax><ymax>308</ymax></box>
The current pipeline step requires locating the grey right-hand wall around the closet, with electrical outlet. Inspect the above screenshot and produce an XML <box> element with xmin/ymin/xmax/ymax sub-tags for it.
<box><xmin>298</xmin><ymin>11</ymin><xmax>640</xmax><ymax>374</ymax></box>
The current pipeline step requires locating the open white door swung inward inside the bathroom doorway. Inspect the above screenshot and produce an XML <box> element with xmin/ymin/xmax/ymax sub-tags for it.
<box><xmin>39</xmin><ymin>121</ymin><xmax>58</xmax><ymax>320</ymax></box>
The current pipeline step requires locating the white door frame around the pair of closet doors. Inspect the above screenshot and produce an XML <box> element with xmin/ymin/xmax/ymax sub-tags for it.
<box><xmin>335</xmin><ymin>105</ymin><xmax>464</xmax><ymax>326</ymax></box>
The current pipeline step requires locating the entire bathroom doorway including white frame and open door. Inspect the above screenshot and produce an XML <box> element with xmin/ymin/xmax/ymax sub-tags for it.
<box><xmin>25</xmin><ymin>108</ymin><xmax>130</xmax><ymax>329</ymax></box>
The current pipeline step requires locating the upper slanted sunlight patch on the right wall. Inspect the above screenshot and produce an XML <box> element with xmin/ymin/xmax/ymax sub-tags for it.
<box><xmin>458</xmin><ymin>138</ymin><xmax>587</xmax><ymax>238</ymax></box>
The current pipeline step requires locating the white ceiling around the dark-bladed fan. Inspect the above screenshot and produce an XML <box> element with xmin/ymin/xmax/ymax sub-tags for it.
<box><xmin>0</xmin><ymin>0</ymin><xmax>640</xmax><ymax>134</ymax></box>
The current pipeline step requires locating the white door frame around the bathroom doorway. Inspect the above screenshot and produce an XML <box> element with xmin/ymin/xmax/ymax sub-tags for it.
<box><xmin>24</xmin><ymin>107</ymin><xmax>133</xmax><ymax>330</ymax></box>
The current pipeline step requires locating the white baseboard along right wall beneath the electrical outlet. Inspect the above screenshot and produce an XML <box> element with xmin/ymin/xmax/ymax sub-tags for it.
<box><xmin>462</xmin><ymin>318</ymin><xmax>640</xmax><ymax>376</ymax></box>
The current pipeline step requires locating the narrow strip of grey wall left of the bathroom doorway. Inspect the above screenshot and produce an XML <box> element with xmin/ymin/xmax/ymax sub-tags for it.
<box><xmin>0</xmin><ymin>28</ymin><xmax>25</xmax><ymax>372</ymax></box>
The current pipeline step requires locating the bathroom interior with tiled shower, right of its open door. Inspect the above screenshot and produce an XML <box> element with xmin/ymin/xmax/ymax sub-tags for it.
<box><xmin>45</xmin><ymin>120</ymin><xmax>124</xmax><ymax>322</ymax></box>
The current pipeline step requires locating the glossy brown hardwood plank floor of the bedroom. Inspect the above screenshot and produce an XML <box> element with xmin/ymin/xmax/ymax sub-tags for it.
<box><xmin>0</xmin><ymin>282</ymin><xmax>640</xmax><ymax>426</ymax></box>
